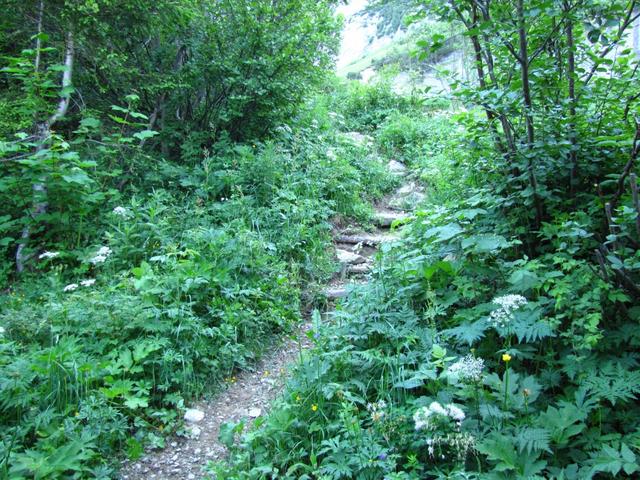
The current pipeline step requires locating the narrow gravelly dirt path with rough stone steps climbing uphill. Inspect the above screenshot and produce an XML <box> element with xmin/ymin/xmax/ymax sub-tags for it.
<box><xmin>120</xmin><ymin>158</ymin><xmax>421</xmax><ymax>480</ymax></box>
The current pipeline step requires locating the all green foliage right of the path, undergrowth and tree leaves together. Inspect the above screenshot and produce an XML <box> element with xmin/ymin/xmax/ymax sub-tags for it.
<box><xmin>210</xmin><ymin>6</ymin><xmax>640</xmax><ymax>472</ymax></box>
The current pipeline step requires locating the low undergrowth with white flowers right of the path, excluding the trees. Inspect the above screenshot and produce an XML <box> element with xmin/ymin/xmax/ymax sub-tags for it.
<box><xmin>210</xmin><ymin>92</ymin><xmax>640</xmax><ymax>480</ymax></box>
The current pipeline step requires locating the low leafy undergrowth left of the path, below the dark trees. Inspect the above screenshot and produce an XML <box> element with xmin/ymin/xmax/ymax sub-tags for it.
<box><xmin>0</xmin><ymin>84</ymin><xmax>395</xmax><ymax>479</ymax></box>
